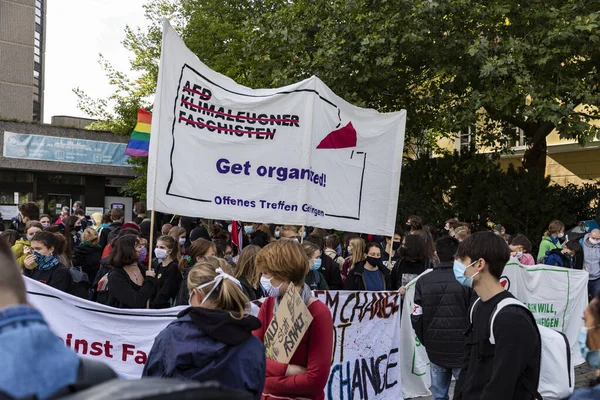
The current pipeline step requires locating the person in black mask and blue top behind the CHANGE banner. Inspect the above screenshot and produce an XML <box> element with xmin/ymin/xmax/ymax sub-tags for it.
<box><xmin>344</xmin><ymin>242</ymin><xmax>391</xmax><ymax>292</ymax></box>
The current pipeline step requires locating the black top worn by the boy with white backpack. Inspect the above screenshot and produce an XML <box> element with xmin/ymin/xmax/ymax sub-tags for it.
<box><xmin>454</xmin><ymin>291</ymin><xmax>541</xmax><ymax>400</ymax></box>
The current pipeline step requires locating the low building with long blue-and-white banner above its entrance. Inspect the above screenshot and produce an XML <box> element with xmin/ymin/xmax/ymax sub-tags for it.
<box><xmin>0</xmin><ymin>120</ymin><xmax>134</xmax><ymax>220</ymax></box>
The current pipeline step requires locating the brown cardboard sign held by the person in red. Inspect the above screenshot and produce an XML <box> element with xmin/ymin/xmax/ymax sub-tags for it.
<box><xmin>264</xmin><ymin>285</ymin><xmax>313</xmax><ymax>364</ymax></box>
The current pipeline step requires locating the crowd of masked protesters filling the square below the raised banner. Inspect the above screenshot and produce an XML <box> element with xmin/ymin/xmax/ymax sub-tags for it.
<box><xmin>0</xmin><ymin>203</ymin><xmax>600</xmax><ymax>400</ymax></box>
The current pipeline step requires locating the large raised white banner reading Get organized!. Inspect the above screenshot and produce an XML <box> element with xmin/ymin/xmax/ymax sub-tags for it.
<box><xmin>148</xmin><ymin>21</ymin><xmax>406</xmax><ymax>235</ymax></box>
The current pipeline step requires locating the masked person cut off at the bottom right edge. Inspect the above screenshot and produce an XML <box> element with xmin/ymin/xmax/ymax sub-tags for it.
<box><xmin>569</xmin><ymin>295</ymin><xmax>600</xmax><ymax>400</ymax></box>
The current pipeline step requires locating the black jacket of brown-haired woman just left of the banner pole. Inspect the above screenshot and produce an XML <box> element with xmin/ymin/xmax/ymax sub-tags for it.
<box><xmin>108</xmin><ymin>267</ymin><xmax>156</xmax><ymax>308</ymax></box>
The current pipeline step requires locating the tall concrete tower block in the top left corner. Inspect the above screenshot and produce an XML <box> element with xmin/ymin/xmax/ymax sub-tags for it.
<box><xmin>0</xmin><ymin>0</ymin><xmax>47</xmax><ymax>121</ymax></box>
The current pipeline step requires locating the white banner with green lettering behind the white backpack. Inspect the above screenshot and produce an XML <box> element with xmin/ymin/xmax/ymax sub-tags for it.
<box><xmin>401</xmin><ymin>258</ymin><xmax>588</xmax><ymax>398</ymax></box>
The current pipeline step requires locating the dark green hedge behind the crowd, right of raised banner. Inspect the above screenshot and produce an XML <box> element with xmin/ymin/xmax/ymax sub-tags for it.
<box><xmin>398</xmin><ymin>152</ymin><xmax>600</xmax><ymax>243</ymax></box>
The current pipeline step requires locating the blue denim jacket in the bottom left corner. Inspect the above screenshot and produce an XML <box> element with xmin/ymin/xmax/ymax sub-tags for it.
<box><xmin>0</xmin><ymin>304</ymin><xmax>79</xmax><ymax>399</ymax></box>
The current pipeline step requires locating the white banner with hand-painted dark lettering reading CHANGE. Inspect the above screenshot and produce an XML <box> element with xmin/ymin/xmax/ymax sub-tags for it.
<box><xmin>315</xmin><ymin>291</ymin><xmax>406</xmax><ymax>400</ymax></box>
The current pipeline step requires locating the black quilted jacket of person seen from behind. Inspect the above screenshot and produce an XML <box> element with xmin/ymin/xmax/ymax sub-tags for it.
<box><xmin>411</xmin><ymin>262</ymin><xmax>476</xmax><ymax>368</ymax></box>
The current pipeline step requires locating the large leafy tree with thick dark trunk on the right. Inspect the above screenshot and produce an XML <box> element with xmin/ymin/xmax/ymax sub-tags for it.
<box><xmin>402</xmin><ymin>0</ymin><xmax>600</xmax><ymax>177</ymax></box>
